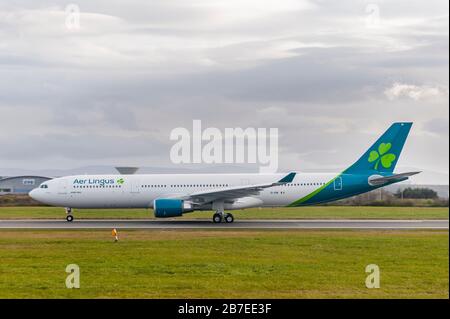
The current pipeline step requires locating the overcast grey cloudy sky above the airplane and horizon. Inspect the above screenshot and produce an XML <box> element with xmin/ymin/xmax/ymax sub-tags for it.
<box><xmin>0</xmin><ymin>0</ymin><xmax>449</xmax><ymax>184</ymax></box>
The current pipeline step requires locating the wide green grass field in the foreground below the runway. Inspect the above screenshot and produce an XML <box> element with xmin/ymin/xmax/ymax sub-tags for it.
<box><xmin>0</xmin><ymin>230</ymin><xmax>449</xmax><ymax>298</ymax></box>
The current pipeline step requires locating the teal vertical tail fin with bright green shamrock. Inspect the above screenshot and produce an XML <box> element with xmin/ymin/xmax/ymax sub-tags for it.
<box><xmin>345</xmin><ymin>122</ymin><xmax>412</xmax><ymax>174</ymax></box>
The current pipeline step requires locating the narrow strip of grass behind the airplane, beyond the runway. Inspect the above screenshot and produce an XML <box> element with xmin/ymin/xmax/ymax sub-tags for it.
<box><xmin>0</xmin><ymin>206</ymin><xmax>449</xmax><ymax>219</ymax></box>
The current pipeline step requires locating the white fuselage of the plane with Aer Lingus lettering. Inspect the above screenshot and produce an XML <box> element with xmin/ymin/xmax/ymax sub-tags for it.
<box><xmin>30</xmin><ymin>173</ymin><xmax>336</xmax><ymax>210</ymax></box>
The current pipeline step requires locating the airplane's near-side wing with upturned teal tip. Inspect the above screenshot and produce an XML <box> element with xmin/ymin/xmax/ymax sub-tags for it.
<box><xmin>182</xmin><ymin>173</ymin><xmax>296</xmax><ymax>204</ymax></box>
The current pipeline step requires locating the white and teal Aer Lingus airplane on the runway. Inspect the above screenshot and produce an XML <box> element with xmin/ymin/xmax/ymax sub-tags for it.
<box><xmin>29</xmin><ymin>122</ymin><xmax>420</xmax><ymax>223</ymax></box>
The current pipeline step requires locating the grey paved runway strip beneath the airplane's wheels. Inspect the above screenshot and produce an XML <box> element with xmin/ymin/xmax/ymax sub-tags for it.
<box><xmin>0</xmin><ymin>219</ymin><xmax>449</xmax><ymax>229</ymax></box>
